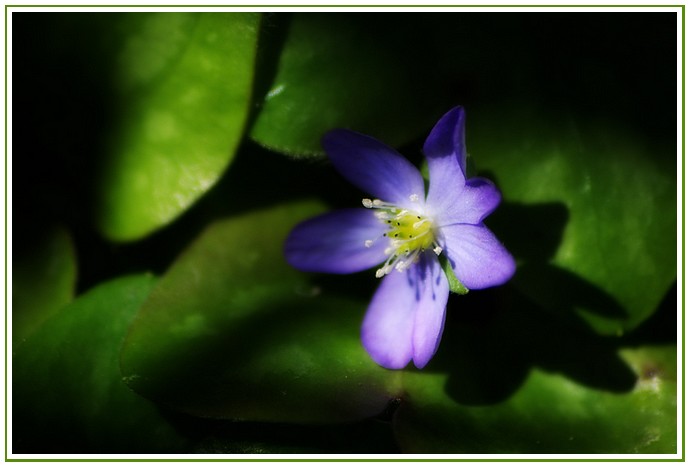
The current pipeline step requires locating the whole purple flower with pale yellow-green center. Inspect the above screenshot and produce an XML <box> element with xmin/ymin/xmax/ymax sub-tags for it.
<box><xmin>285</xmin><ymin>107</ymin><xmax>515</xmax><ymax>369</ymax></box>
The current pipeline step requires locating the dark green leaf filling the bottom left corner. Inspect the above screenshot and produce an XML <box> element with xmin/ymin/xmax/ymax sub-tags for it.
<box><xmin>12</xmin><ymin>275</ymin><xmax>185</xmax><ymax>453</ymax></box>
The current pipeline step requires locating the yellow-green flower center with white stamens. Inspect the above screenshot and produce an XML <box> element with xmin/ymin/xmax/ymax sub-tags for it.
<box><xmin>362</xmin><ymin>195</ymin><xmax>443</xmax><ymax>277</ymax></box>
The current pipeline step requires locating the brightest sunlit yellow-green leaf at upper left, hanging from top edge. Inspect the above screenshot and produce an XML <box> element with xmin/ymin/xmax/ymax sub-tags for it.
<box><xmin>98</xmin><ymin>13</ymin><xmax>259</xmax><ymax>241</ymax></box>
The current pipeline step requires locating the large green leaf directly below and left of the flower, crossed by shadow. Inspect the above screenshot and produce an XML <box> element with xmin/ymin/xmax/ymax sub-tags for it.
<box><xmin>122</xmin><ymin>203</ymin><xmax>391</xmax><ymax>423</ymax></box>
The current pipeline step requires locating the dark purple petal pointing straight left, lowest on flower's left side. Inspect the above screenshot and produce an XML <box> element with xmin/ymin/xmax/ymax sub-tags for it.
<box><xmin>285</xmin><ymin>208</ymin><xmax>388</xmax><ymax>274</ymax></box>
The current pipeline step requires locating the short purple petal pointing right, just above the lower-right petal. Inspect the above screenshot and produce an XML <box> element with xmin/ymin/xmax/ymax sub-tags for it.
<box><xmin>427</xmin><ymin>177</ymin><xmax>501</xmax><ymax>226</ymax></box>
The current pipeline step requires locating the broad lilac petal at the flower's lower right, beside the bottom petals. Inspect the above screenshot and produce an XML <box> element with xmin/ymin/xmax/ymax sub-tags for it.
<box><xmin>440</xmin><ymin>224</ymin><xmax>515</xmax><ymax>289</ymax></box>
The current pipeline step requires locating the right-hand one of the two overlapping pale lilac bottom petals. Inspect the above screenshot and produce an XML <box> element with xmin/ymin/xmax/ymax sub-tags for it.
<box><xmin>412</xmin><ymin>255</ymin><xmax>449</xmax><ymax>368</ymax></box>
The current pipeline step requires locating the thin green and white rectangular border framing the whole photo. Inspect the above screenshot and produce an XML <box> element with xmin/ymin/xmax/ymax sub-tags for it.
<box><xmin>4</xmin><ymin>4</ymin><xmax>685</xmax><ymax>462</ymax></box>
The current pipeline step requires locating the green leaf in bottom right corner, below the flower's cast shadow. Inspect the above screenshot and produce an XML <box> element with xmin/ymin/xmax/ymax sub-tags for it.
<box><xmin>394</xmin><ymin>346</ymin><xmax>677</xmax><ymax>454</ymax></box>
